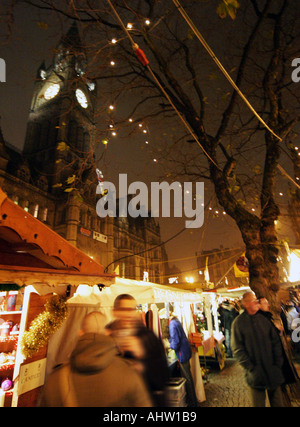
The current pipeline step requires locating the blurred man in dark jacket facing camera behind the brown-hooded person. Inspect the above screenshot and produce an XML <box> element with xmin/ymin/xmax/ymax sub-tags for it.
<box><xmin>106</xmin><ymin>294</ymin><xmax>169</xmax><ymax>407</ymax></box>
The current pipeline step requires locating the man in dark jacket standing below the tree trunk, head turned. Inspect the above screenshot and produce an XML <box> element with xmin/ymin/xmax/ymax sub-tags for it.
<box><xmin>231</xmin><ymin>292</ymin><xmax>284</xmax><ymax>407</ymax></box>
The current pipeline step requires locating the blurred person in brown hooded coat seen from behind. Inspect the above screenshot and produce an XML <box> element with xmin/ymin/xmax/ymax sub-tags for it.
<box><xmin>40</xmin><ymin>312</ymin><xmax>152</xmax><ymax>407</ymax></box>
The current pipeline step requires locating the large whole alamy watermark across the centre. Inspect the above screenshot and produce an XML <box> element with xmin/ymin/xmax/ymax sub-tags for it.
<box><xmin>96</xmin><ymin>170</ymin><xmax>204</xmax><ymax>228</ymax></box>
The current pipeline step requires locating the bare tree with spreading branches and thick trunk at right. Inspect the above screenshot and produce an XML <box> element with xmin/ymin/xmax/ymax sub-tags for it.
<box><xmin>5</xmin><ymin>0</ymin><xmax>300</xmax><ymax>314</ymax></box>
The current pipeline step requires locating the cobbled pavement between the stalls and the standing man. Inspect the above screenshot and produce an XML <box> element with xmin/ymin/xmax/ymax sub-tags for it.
<box><xmin>198</xmin><ymin>359</ymin><xmax>300</xmax><ymax>407</ymax></box>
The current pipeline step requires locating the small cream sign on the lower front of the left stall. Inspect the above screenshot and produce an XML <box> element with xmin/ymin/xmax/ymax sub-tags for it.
<box><xmin>18</xmin><ymin>357</ymin><xmax>47</xmax><ymax>395</ymax></box>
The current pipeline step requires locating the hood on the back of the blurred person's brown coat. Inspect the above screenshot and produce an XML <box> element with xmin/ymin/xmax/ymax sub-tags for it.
<box><xmin>70</xmin><ymin>333</ymin><xmax>118</xmax><ymax>373</ymax></box>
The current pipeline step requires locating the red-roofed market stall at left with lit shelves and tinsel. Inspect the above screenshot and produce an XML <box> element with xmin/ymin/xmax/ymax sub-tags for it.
<box><xmin>0</xmin><ymin>189</ymin><xmax>113</xmax><ymax>406</ymax></box>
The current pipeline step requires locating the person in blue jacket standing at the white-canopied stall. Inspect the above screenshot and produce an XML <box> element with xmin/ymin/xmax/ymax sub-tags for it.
<box><xmin>169</xmin><ymin>314</ymin><xmax>198</xmax><ymax>407</ymax></box>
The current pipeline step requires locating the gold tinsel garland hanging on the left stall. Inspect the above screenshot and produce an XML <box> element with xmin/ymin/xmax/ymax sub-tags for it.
<box><xmin>21</xmin><ymin>295</ymin><xmax>68</xmax><ymax>359</ymax></box>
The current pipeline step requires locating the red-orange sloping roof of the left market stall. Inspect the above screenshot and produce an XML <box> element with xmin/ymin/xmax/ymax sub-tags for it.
<box><xmin>0</xmin><ymin>188</ymin><xmax>112</xmax><ymax>283</ymax></box>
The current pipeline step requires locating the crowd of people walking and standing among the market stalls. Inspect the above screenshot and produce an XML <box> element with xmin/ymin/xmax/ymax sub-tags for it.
<box><xmin>40</xmin><ymin>292</ymin><xmax>300</xmax><ymax>407</ymax></box>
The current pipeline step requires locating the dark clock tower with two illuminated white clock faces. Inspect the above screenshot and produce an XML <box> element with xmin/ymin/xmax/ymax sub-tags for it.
<box><xmin>23</xmin><ymin>23</ymin><xmax>96</xmax><ymax>192</ymax></box>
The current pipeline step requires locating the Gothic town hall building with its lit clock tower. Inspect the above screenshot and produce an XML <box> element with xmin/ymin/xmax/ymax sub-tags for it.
<box><xmin>0</xmin><ymin>24</ymin><xmax>167</xmax><ymax>283</ymax></box>
